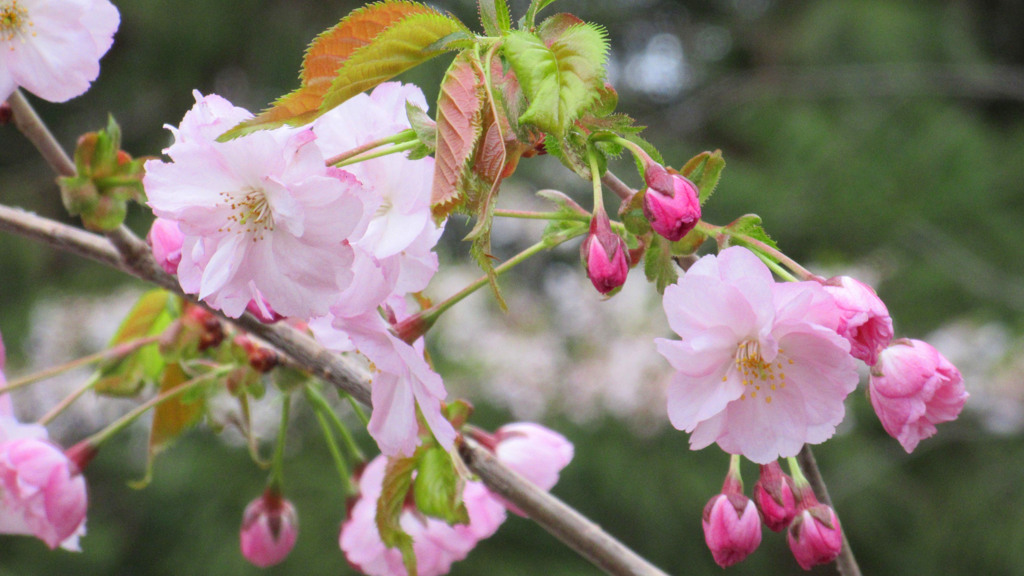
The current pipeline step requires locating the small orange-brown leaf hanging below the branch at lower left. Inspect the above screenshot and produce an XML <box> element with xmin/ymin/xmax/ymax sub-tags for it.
<box><xmin>129</xmin><ymin>363</ymin><xmax>206</xmax><ymax>490</ymax></box>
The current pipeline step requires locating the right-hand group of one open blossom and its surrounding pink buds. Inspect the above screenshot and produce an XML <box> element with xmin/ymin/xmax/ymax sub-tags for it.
<box><xmin>656</xmin><ymin>247</ymin><xmax>968</xmax><ymax>569</ymax></box>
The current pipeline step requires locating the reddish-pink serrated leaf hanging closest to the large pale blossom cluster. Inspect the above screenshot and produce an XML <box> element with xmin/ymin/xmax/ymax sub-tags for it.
<box><xmin>430</xmin><ymin>51</ymin><xmax>485</xmax><ymax>219</ymax></box>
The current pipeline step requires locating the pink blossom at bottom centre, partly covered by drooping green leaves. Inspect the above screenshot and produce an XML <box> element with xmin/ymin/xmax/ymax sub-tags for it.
<box><xmin>338</xmin><ymin>456</ymin><xmax>505</xmax><ymax>576</ymax></box>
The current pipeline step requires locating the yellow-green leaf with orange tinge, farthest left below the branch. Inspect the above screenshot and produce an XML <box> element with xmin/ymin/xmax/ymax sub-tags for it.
<box><xmin>94</xmin><ymin>290</ymin><xmax>178</xmax><ymax>396</ymax></box>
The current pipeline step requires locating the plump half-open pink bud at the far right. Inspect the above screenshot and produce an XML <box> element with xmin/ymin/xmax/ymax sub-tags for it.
<box><xmin>868</xmin><ymin>339</ymin><xmax>968</xmax><ymax>453</ymax></box>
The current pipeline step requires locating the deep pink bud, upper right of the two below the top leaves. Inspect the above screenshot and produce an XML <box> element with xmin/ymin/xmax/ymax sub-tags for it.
<box><xmin>643</xmin><ymin>162</ymin><xmax>700</xmax><ymax>242</ymax></box>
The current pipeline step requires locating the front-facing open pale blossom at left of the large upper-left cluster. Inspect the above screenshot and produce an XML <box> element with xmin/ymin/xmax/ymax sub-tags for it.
<box><xmin>143</xmin><ymin>95</ymin><xmax>362</xmax><ymax>318</ymax></box>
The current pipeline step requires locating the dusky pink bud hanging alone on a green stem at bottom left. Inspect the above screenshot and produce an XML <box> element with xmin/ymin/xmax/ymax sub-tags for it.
<box><xmin>240</xmin><ymin>489</ymin><xmax>299</xmax><ymax>568</ymax></box>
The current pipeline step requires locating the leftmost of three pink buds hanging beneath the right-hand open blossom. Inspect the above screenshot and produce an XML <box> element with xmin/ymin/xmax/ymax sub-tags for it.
<box><xmin>701</xmin><ymin>493</ymin><xmax>761</xmax><ymax>568</ymax></box>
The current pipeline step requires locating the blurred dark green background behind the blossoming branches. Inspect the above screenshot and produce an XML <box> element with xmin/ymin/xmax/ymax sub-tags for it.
<box><xmin>0</xmin><ymin>0</ymin><xmax>1024</xmax><ymax>576</ymax></box>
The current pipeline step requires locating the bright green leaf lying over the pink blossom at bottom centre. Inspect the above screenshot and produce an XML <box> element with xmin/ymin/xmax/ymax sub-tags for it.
<box><xmin>413</xmin><ymin>446</ymin><xmax>469</xmax><ymax>525</ymax></box>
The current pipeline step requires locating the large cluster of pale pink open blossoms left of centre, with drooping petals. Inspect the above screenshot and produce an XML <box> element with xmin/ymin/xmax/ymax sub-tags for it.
<box><xmin>143</xmin><ymin>83</ymin><xmax>455</xmax><ymax>455</ymax></box>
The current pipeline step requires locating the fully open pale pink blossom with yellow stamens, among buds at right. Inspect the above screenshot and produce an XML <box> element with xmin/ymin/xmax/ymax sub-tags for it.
<box><xmin>655</xmin><ymin>247</ymin><xmax>858</xmax><ymax>464</ymax></box>
